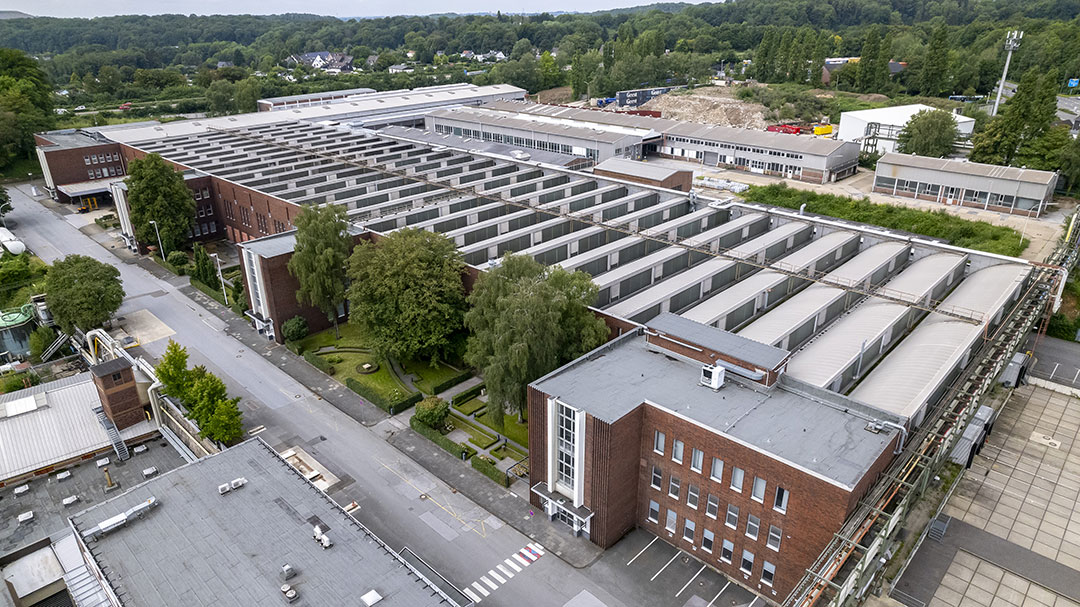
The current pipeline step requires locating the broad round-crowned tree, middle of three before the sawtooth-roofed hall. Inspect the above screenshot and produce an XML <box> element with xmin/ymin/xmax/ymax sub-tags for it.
<box><xmin>349</xmin><ymin>229</ymin><xmax>465</xmax><ymax>361</ymax></box>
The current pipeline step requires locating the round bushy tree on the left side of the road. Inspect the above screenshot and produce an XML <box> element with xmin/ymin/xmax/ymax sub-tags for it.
<box><xmin>45</xmin><ymin>255</ymin><xmax>124</xmax><ymax>335</ymax></box>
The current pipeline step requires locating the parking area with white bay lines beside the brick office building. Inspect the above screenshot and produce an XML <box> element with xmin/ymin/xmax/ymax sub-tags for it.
<box><xmin>590</xmin><ymin>529</ymin><xmax>765</xmax><ymax>607</ymax></box>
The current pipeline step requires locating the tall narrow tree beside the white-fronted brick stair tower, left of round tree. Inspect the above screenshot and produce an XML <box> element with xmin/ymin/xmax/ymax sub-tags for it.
<box><xmin>288</xmin><ymin>204</ymin><xmax>352</xmax><ymax>337</ymax></box>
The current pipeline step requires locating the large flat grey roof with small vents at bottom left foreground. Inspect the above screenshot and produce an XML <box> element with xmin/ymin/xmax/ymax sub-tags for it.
<box><xmin>71</xmin><ymin>439</ymin><xmax>448</xmax><ymax>607</ymax></box>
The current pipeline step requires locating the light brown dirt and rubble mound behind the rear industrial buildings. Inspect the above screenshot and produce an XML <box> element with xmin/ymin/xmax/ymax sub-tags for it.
<box><xmin>640</xmin><ymin>86</ymin><xmax>770</xmax><ymax>129</ymax></box>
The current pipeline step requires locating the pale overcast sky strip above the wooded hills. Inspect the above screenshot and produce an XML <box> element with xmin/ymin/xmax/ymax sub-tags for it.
<box><xmin>6</xmin><ymin>0</ymin><xmax>701</xmax><ymax>17</ymax></box>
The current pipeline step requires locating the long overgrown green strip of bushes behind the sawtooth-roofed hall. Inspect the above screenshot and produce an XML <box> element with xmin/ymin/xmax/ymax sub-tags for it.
<box><xmin>745</xmin><ymin>184</ymin><xmax>1028</xmax><ymax>257</ymax></box>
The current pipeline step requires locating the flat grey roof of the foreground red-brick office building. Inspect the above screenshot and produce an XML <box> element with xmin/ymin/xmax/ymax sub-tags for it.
<box><xmin>532</xmin><ymin>325</ymin><xmax>894</xmax><ymax>490</ymax></box>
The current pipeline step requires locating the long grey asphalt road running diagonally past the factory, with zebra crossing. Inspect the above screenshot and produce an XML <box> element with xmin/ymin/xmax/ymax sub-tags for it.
<box><xmin>8</xmin><ymin>185</ymin><xmax>752</xmax><ymax>607</ymax></box>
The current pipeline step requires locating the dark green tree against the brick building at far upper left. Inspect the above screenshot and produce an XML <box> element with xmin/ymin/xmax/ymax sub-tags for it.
<box><xmin>124</xmin><ymin>153</ymin><xmax>195</xmax><ymax>255</ymax></box>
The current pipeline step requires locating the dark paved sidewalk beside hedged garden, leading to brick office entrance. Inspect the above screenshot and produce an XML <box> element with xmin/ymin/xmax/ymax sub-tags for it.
<box><xmin>388</xmin><ymin>430</ymin><xmax>604</xmax><ymax>569</ymax></box>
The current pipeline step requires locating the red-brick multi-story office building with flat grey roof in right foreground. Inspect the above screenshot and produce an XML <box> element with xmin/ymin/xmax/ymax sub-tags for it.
<box><xmin>529</xmin><ymin>314</ymin><xmax>900</xmax><ymax>601</ymax></box>
